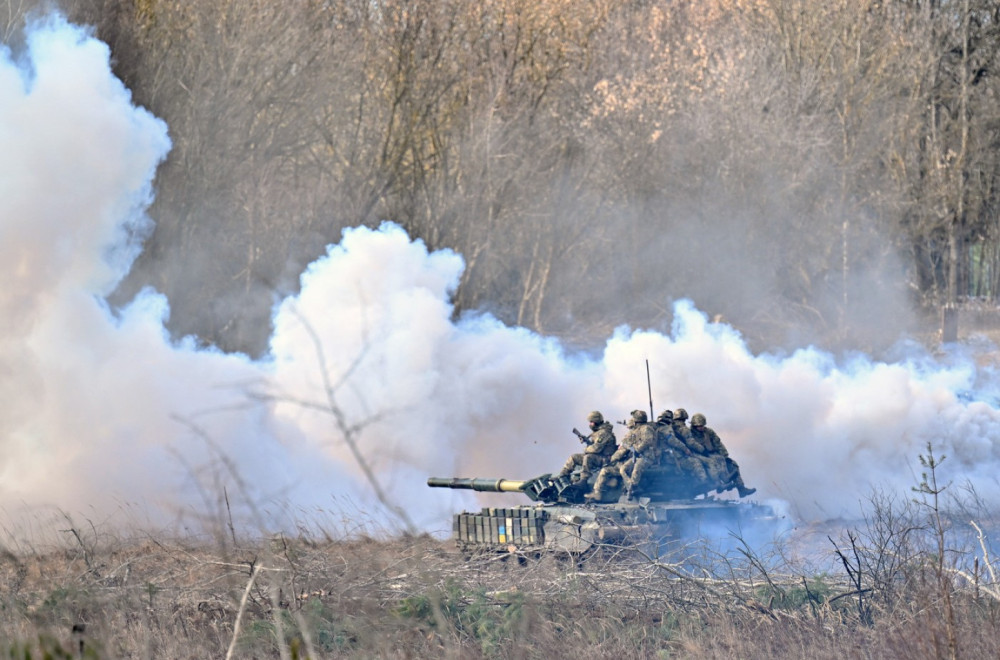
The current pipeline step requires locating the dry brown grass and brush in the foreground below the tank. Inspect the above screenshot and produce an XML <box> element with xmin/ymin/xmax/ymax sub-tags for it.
<box><xmin>0</xmin><ymin>462</ymin><xmax>1000</xmax><ymax>659</ymax></box>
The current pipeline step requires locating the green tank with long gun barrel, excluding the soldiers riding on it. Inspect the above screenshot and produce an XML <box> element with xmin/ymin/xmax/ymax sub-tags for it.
<box><xmin>427</xmin><ymin>458</ymin><xmax>775</xmax><ymax>557</ymax></box>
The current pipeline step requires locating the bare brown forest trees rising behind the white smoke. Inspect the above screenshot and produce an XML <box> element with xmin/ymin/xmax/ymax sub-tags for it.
<box><xmin>7</xmin><ymin>0</ymin><xmax>1000</xmax><ymax>355</ymax></box>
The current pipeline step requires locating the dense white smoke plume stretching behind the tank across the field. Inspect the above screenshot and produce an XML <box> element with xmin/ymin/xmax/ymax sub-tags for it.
<box><xmin>0</xmin><ymin>19</ymin><xmax>1000</xmax><ymax>531</ymax></box>
